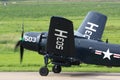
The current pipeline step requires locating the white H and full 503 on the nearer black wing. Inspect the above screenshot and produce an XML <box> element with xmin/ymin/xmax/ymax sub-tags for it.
<box><xmin>54</xmin><ymin>29</ymin><xmax>68</xmax><ymax>50</ymax></box>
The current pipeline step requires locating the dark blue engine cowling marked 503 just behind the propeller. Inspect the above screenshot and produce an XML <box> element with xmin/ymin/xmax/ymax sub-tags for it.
<box><xmin>22</xmin><ymin>32</ymin><xmax>41</xmax><ymax>51</ymax></box>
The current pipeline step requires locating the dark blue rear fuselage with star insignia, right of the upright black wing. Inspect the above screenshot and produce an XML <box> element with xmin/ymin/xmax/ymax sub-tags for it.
<box><xmin>75</xmin><ymin>38</ymin><xmax>120</xmax><ymax>66</ymax></box>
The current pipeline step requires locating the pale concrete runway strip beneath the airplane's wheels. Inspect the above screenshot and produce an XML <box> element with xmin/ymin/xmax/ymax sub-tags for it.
<box><xmin>0</xmin><ymin>72</ymin><xmax>120</xmax><ymax>80</ymax></box>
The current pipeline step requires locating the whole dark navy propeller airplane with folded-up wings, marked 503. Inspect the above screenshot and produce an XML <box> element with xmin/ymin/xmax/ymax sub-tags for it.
<box><xmin>15</xmin><ymin>11</ymin><xmax>120</xmax><ymax>76</ymax></box>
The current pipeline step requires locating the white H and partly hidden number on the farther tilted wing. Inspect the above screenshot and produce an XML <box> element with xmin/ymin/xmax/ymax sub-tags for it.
<box><xmin>84</xmin><ymin>22</ymin><xmax>99</xmax><ymax>39</ymax></box>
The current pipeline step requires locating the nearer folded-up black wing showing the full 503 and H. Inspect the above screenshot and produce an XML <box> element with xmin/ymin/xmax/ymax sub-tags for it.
<box><xmin>47</xmin><ymin>16</ymin><xmax>75</xmax><ymax>57</ymax></box>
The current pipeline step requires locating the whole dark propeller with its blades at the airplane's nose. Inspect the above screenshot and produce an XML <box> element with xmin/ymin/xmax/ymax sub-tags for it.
<box><xmin>14</xmin><ymin>24</ymin><xmax>24</xmax><ymax>63</ymax></box>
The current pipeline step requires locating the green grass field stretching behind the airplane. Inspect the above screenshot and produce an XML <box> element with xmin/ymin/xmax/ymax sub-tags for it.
<box><xmin>0</xmin><ymin>0</ymin><xmax>120</xmax><ymax>72</ymax></box>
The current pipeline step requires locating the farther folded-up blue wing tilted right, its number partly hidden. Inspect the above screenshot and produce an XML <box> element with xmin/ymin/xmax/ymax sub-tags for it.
<box><xmin>77</xmin><ymin>11</ymin><xmax>107</xmax><ymax>40</ymax></box>
